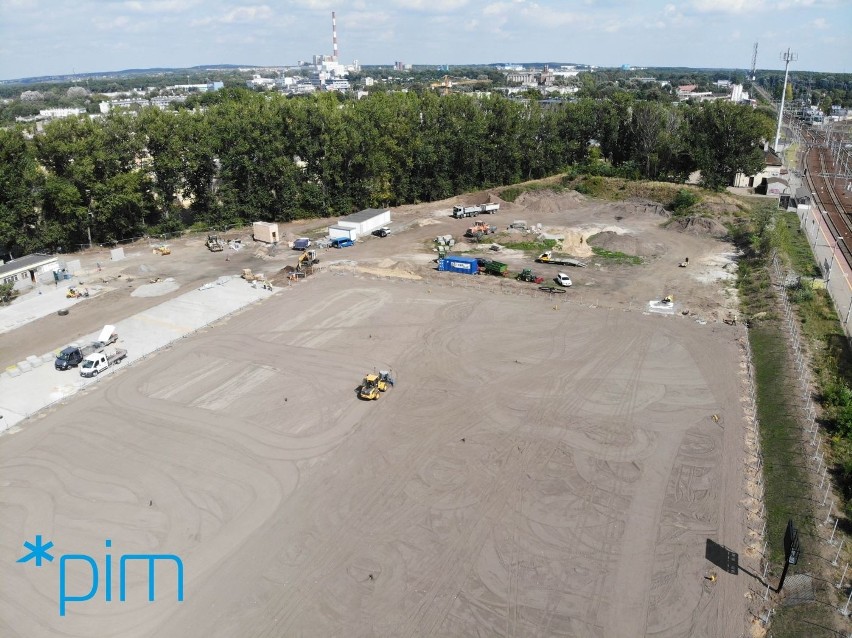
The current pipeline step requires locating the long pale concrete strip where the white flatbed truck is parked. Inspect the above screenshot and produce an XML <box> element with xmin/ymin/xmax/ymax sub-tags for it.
<box><xmin>0</xmin><ymin>278</ymin><xmax>275</xmax><ymax>432</ymax></box>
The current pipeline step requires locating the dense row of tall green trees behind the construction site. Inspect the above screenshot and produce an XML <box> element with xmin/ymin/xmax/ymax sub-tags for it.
<box><xmin>0</xmin><ymin>89</ymin><xmax>771</xmax><ymax>255</ymax></box>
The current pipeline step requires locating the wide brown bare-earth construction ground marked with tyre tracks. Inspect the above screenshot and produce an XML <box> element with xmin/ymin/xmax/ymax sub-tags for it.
<box><xmin>0</xmin><ymin>191</ymin><xmax>750</xmax><ymax>638</ymax></box>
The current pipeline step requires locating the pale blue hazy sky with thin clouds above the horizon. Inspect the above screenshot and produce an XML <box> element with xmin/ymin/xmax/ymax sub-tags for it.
<box><xmin>0</xmin><ymin>0</ymin><xmax>852</xmax><ymax>80</ymax></box>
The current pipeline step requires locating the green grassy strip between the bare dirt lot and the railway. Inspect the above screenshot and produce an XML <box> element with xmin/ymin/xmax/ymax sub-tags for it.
<box><xmin>731</xmin><ymin>205</ymin><xmax>852</xmax><ymax>638</ymax></box>
